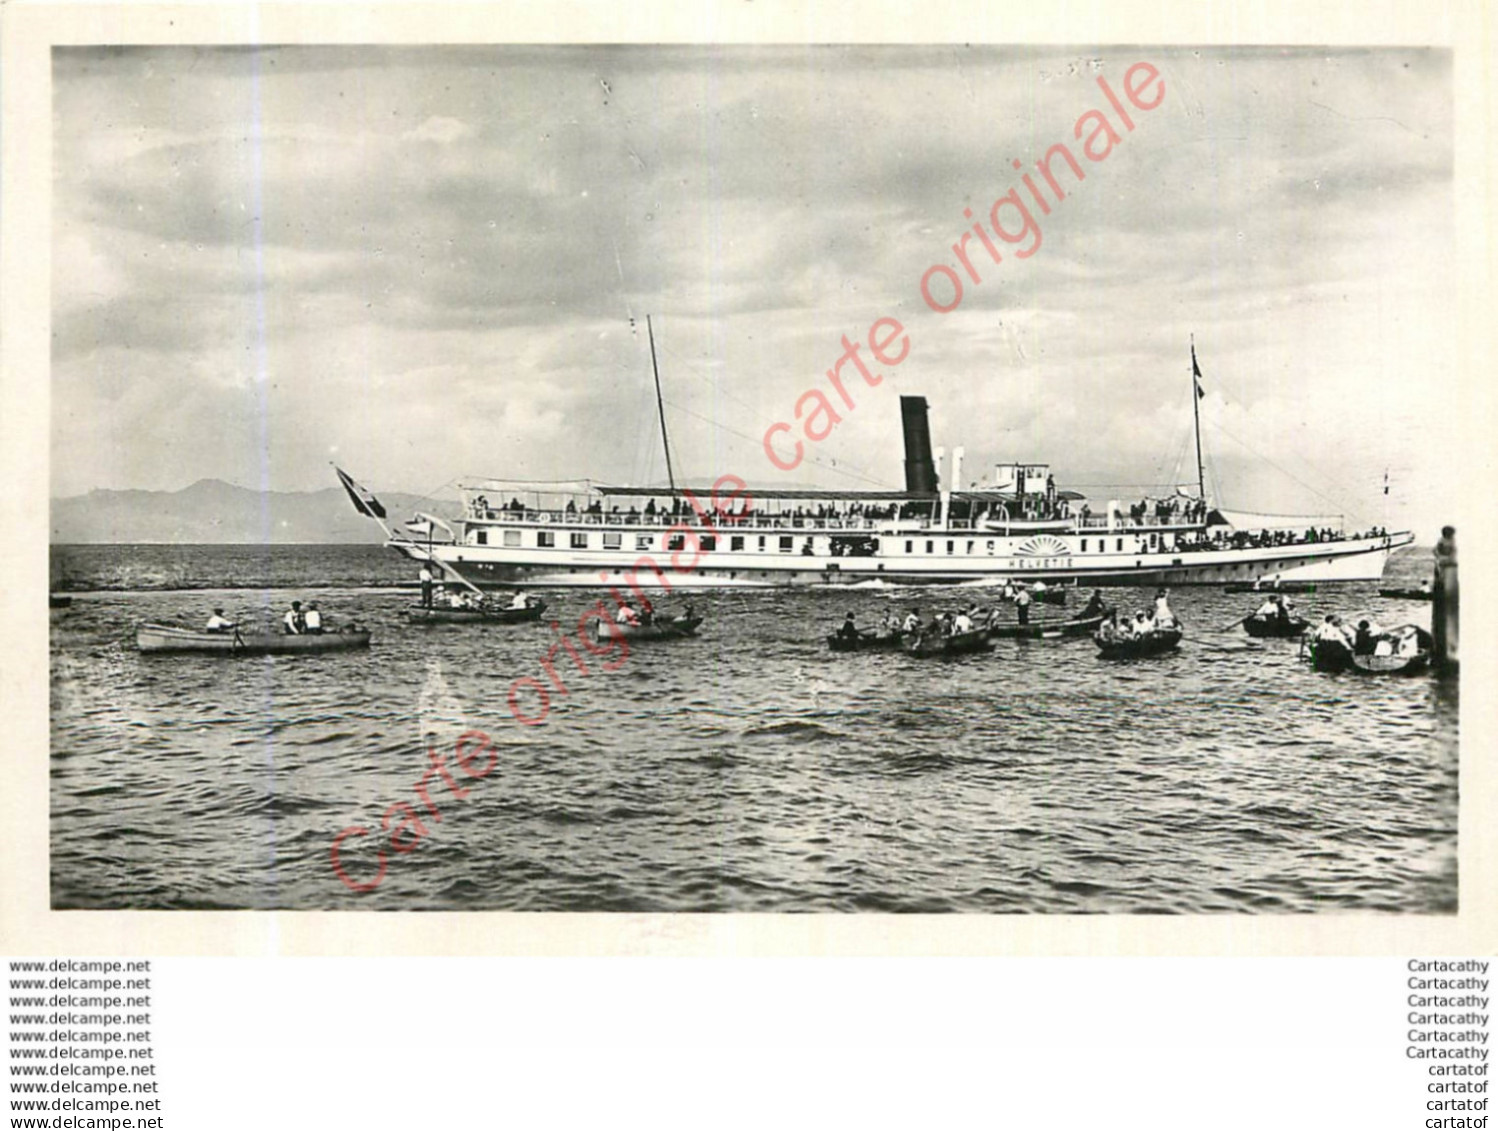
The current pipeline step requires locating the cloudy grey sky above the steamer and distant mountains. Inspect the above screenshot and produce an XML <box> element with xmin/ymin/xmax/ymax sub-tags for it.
<box><xmin>52</xmin><ymin>48</ymin><xmax>1455</xmax><ymax>533</ymax></box>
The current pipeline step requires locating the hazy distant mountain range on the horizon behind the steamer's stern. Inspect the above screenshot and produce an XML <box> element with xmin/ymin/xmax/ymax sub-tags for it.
<box><xmin>52</xmin><ymin>479</ymin><xmax>455</xmax><ymax>545</ymax></box>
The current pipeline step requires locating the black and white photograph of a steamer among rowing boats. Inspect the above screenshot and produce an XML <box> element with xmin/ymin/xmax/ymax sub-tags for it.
<box><xmin>49</xmin><ymin>43</ymin><xmax>1467</xmax><ymax>918</ymax></box>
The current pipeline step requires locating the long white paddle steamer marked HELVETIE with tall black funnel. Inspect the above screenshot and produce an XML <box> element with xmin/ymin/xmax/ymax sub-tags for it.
<box><xmin>388</xmin><ymin>367</ymin><xmax>1414</xmax><ymax>590</ymax></box>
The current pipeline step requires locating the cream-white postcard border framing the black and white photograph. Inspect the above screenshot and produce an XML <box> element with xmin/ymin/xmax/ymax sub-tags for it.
<box><xmin>0</xmin><ymin>0</ymin><xmax>1498</xmax><ymax>956</ymax></box>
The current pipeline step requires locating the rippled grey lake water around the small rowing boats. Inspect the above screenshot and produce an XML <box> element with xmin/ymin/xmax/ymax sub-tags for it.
<box><xmin>51</xmin><ymin>547</ymin><xmax>1458</xmax><ymax>914</ymax></box>
